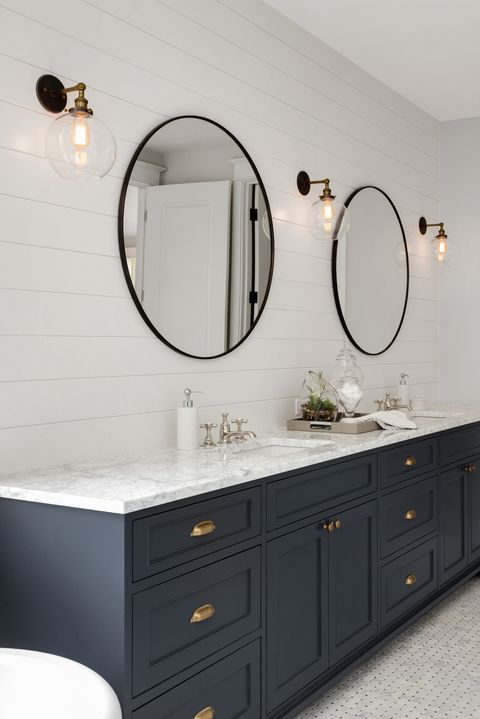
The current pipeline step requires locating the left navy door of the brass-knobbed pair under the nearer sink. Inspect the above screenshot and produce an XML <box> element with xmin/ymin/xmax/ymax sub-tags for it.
<box><xmin>267</xmin><ymin>523</ymin><xmax>329</xmax><ymax>711</ymax></box>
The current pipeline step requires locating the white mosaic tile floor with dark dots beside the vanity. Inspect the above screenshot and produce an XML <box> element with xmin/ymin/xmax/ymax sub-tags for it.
<box><xmin>297</xmin><ymin>577</ymin><xmax>480</xmax><ymax>719</ymax></box>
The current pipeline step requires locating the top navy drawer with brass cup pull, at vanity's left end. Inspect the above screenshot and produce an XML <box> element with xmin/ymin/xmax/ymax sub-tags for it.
<box><xmin>133</xmin><ymin>487</ymin><xmax>261</xmax><ymax>581</ymax></box>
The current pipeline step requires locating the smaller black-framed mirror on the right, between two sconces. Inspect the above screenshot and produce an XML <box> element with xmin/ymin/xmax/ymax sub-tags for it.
<box><xmin>332</xmin><ymin>187</ymin><xmax>409</xmax><ymax>355</ymax></box>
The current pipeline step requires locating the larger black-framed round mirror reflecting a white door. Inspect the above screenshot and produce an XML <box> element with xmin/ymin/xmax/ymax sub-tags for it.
<box><xmin>119</xmin><ymin>116</ymin><xmax>274</xmax><ymax>359</ymax></box>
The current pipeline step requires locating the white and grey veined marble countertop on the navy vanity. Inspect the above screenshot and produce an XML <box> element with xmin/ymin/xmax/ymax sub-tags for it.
<box><xmin>0</xmin><ymin>408</ymin><xmax>480</xmax><ymax>514</ymax></box>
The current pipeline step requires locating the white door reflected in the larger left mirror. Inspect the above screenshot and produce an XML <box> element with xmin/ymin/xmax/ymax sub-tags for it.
<box><xmin>142</xmin><ymin>181</ymin><xmax>231</xmax><ymax>356</ymax></box>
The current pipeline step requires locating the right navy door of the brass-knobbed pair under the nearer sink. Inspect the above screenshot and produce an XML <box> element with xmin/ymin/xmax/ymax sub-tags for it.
<box><xmin>328</xmin><ymin>501</ymin><xmax>378</xmax><ymax>664</ymax></box>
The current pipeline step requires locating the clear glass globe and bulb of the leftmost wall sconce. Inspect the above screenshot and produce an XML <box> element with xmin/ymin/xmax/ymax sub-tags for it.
<box><xmin>45</xmin><ymin>112</ymin><xmax>117</xmax><ymax>180</ymax></box>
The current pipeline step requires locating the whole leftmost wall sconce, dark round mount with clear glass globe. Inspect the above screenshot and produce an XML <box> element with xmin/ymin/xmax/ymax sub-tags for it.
<box><xmin>36</xmin><ymin>75</ymin><xmax>116</xmax><ymax>180</ymax></box>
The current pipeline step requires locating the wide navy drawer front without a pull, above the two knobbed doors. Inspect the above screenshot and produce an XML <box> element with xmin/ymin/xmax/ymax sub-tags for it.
<box><xmin>267</xmin><ymin>455</ymin><xmax>377</xmax><ymax>529</ymax></box>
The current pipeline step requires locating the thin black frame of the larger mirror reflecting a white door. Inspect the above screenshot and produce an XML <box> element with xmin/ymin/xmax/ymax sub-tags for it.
<box><xmin>118</xmin><ymin>115</ymin><xmax>275</xmax><ymax>360</ymax></box>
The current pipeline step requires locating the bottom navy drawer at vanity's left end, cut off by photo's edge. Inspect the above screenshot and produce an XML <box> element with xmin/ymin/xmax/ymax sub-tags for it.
<box><xmin>132</xmin><ymin>641</ymin><xmax>260</xmax><ymax>719</ymax></box>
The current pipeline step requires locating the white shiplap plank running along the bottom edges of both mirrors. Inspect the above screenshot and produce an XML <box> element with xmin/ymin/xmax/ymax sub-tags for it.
<box><xmin>0</xmin><ymin>335</ymin><xmax>436</xmax><ymax>386</ymax></box>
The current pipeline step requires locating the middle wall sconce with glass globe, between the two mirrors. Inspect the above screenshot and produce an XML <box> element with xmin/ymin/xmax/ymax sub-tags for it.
<box><xmin>297</xmin><ymin>170</ymin><xmax>350</xmax><ymax>240</ymax></box>
